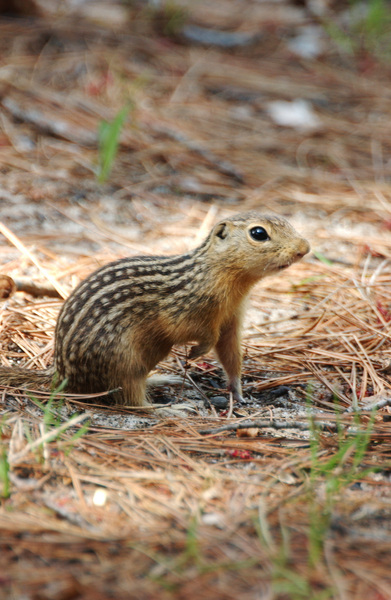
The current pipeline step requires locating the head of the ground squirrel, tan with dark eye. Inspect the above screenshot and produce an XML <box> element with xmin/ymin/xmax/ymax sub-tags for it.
<box><xmin>210</xmin><ymin>211</ymin><xmax>310</xmax><ymax>280</ymax></box>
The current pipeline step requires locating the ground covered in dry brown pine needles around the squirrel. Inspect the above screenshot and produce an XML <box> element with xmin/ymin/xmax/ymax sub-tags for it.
<box><xmin>0</xmin><ymin>0</ymin><xmax>391</xmax><ymax>600</ymax></box>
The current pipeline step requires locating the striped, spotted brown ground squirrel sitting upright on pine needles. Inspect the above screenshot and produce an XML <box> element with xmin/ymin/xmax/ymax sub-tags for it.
<box><xmin>0</xmin><ymin>211</ymin><xmax>310</xmax><ymax>406</ymax></box>
